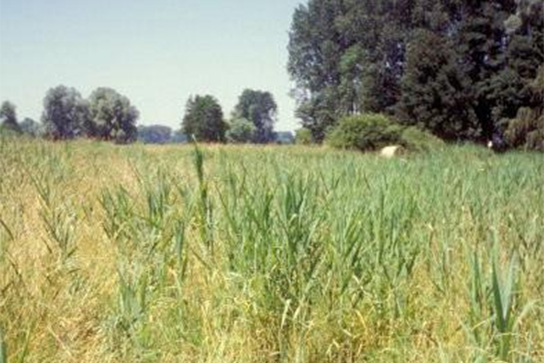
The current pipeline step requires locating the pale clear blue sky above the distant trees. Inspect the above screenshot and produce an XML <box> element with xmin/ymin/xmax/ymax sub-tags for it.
<box><xmin>0</xmin><ymin>0</ymin><xmax>301</xmax><ymax>130</ymax></box>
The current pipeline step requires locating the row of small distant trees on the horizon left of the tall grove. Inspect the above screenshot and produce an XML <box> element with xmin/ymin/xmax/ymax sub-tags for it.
<box><xmin>0</xmin><ymin>85</ymin><xmax>292</xmax><ymax>144</ymax></box>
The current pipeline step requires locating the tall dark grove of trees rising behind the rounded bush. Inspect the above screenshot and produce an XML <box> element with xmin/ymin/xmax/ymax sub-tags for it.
<box><xmin>288</xmin><ymin>0</ymin><xmax>544</xmax><ymax>149</ymax></box>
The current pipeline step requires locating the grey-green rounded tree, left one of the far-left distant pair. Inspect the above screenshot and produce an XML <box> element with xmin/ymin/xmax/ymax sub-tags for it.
<box><xmin>42</xmin><ymin>85</ymin><xmax>89</xmax><ymax>140</ymax></box>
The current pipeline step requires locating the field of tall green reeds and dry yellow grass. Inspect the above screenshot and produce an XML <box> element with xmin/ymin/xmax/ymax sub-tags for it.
<box><xmin>0</xmin><ymin>140</ymin><xmax>544</xmax><ymax>362</ymax></box>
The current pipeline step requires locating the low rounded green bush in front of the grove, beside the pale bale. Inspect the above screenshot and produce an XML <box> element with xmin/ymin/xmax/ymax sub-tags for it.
<box><xmin>326</xmin><ymin>114</ymin><xmax>402</xmax><ymax>151</ymax></box>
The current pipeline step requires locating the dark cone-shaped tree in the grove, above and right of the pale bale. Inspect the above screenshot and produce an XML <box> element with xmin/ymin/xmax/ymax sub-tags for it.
<box><xmin>397</xmin><ymin>30</ymin><xmax>480</xmax><ymax>140</ymax></box>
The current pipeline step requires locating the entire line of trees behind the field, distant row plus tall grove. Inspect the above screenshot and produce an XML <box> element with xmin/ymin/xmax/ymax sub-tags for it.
<box><xmin>0</xmin><ymin>0</ymin><xmax>544</xmax><ymax>150</ymax></box>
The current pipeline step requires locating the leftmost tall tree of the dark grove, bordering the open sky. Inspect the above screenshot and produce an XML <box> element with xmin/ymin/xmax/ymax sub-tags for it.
<box><xmin>288</xmin><ymin>0</ymin><xmax>349</xmax><ymax>141</ymax></box>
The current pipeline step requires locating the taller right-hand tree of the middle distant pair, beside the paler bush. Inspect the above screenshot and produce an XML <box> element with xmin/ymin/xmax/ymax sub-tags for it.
<box><xmin>234</xmin><ymin>89</ymin><xmax>278</xmax><ymax>143</ymax></box>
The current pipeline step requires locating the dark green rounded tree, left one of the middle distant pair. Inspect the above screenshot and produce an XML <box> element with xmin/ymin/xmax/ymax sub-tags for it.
<box><xmin>182</xmin><ymin>95</ymin><xmax>227</xmax><ymax>142</ymax></box>
